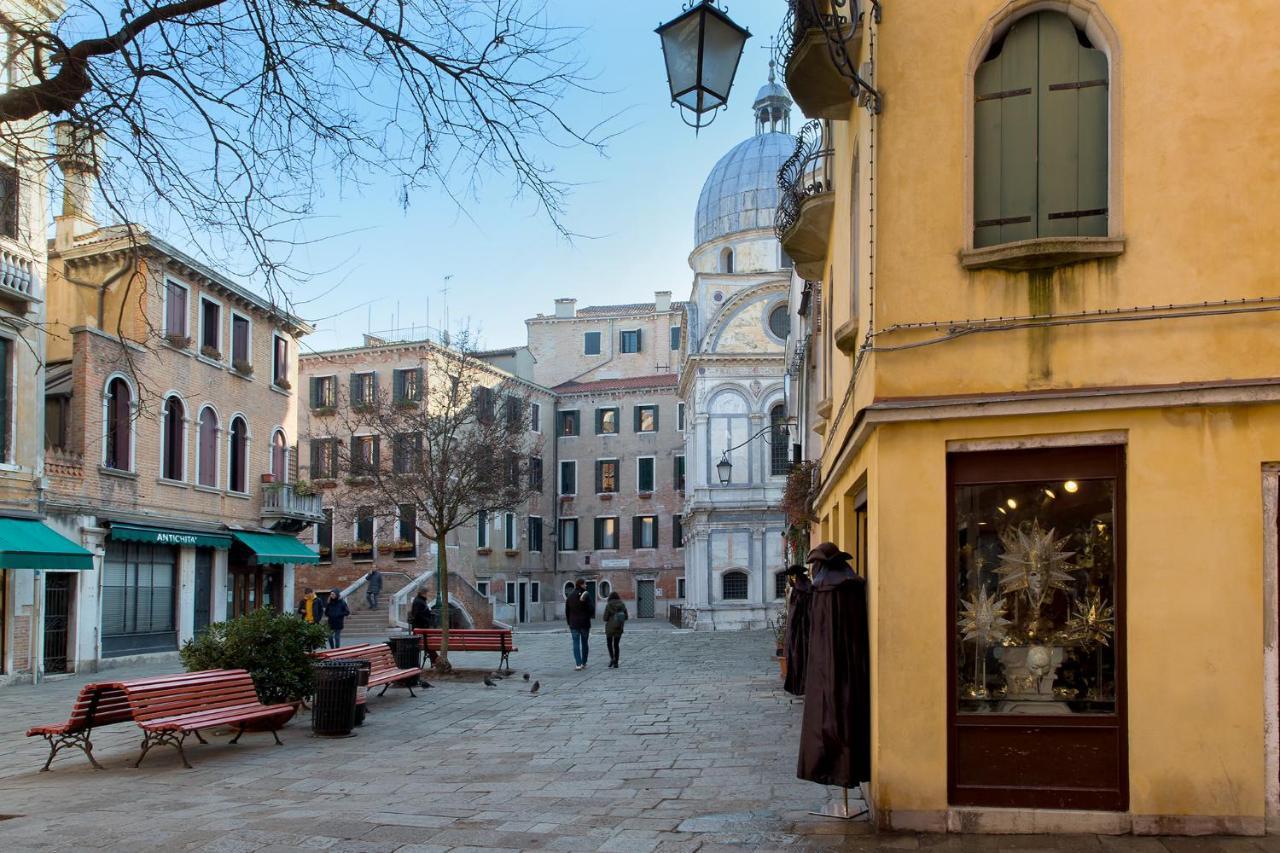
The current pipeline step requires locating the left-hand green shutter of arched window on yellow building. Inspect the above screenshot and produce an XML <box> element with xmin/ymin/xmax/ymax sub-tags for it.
<box><xmin>973</xmin><ymin>15</ymin><xmax>1039</xmax><ymax>247</ymax></box>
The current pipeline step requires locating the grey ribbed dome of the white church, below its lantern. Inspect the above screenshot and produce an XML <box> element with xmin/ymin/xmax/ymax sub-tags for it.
<box><xmin>694</xmin><ymin>132</ymin><xmax>796</xmax><ymax>246</ymax></box>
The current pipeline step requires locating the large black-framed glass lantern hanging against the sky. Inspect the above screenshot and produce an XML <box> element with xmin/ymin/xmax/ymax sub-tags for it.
<box><xmin>655</xmin><ymin>0</ymin><xmax>751</xmax><ymax>133</ymax></box>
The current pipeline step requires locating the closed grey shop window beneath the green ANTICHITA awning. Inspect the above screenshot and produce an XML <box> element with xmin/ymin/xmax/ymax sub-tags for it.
<box><xmin>102</xmin><ymin>540</ymin><xmax>178</xmax><ymax>657</ymax></box>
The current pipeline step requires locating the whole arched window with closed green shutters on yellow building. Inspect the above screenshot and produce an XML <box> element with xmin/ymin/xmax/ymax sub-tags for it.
<box><xmin>973</xmin><ymin>12</ymin><xmax>1108</xmax><ymax>248</ymax></box>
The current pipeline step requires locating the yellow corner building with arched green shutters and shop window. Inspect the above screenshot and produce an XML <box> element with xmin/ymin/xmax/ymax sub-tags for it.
<box><xmin>780</xmin><ymin>0</ymin><xmax>1280</xmax><ymax>834</ymax></box>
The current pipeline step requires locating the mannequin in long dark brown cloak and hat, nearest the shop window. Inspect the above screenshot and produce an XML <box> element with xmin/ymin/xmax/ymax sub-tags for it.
<box><xmin>796</xmin><ymin>542</ymin><xmax>872</xmax><ymax>788</ymax></box>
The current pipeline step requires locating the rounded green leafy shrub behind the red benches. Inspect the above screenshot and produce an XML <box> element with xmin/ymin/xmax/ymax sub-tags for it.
<box><xmin>179</xmin><ymin>607</ymin><xmax>329</xmax><ymax>701</ymax></box>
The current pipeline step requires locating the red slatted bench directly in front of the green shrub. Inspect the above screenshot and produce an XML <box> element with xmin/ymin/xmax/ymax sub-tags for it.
<box><xmin>110</xmin><ymin>670</ymin><xmax>296</xmax><ymax>768</ymax></box>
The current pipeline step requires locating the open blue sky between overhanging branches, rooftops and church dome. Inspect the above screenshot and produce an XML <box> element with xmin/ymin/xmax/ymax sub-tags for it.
<box><xmin>292</xmin><ymin>0</ymin><xmax>796</xmax><ymax>350</ymax></box>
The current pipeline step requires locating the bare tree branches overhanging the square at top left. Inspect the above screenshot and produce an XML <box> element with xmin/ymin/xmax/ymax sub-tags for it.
<box><xmin>0</xmin><ymin>0</ymin><xmax>603</xmax><ymax>302</ymax></box>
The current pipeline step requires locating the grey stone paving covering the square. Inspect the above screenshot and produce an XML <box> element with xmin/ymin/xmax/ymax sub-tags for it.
<box><xmin>0</xmin><ymin>622</ymin><xmax>1280</xmax><ymax>853</ymax></box>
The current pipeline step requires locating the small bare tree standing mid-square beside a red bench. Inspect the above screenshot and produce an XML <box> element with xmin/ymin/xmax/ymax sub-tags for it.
<box><xmin>333</xmin><ymin>341</ymin><xmax>541</xmax><ymax>671</ymax></box>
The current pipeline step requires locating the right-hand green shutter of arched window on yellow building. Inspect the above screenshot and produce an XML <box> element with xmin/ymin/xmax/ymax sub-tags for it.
<box><xmin>1034</xmin><ymin>12</ymin><xmax>1107</xmax><ymax>237</ymax></box>
